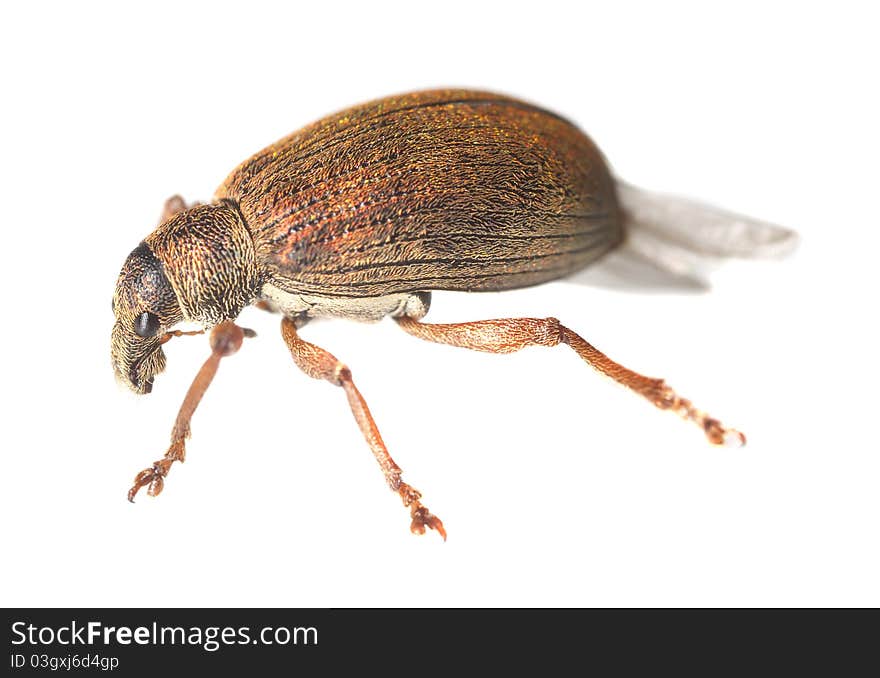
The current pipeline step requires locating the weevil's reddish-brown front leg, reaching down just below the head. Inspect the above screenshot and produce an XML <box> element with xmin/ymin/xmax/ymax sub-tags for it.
<box><xmin>128</xmin><ymin>320</ymin><xmax>254</xmax><ymax>501</ymax></box>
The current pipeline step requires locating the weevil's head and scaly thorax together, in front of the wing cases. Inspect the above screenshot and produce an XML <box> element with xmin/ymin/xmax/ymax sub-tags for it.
<box><xmin>110</xmin><ymin>202</ymin><xmax>261</xmax><ymax>393</ymax></box>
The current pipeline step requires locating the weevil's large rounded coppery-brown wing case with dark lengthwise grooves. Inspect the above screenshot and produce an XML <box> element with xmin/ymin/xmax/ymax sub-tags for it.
<box><xmin>217</xmin><ymin>90</ymin><xmax>623</xmax><ymax>297</ymax></box>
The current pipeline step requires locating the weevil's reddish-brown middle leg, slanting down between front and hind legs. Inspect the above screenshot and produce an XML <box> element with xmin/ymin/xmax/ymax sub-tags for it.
<box><xmin>281</xmin><ymin>318</ymin><xmax>446</xmax><ymax>541</ymax></box>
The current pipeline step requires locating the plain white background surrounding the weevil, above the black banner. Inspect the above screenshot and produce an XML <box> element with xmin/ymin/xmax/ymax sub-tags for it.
<box><xmin>0</xmin><ymin>1</ymin><xmax>880</xmax><ymax>606</ymax></box>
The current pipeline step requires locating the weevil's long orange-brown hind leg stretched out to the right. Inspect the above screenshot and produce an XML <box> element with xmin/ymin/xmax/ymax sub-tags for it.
<box><xmin>397</xmin><ymin>316</ymin><xmax>746</xmax><ymax>445</ymax></box>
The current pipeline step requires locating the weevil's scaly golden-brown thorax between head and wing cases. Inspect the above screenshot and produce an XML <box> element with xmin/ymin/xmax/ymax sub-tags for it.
<box><xmin>145</xmin><ymin>201</ymin><xmax>260</xmax><ymax>327</ymax></box>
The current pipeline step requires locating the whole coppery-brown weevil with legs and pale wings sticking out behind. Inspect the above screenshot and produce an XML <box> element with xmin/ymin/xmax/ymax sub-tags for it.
<box><xmin>111</xmin><ymin>90</ymin><xmax>794</xmax><ymax>539</ymax></box>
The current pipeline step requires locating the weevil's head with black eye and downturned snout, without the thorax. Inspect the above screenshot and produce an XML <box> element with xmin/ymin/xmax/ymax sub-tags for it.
<box><xmin>110</xmin><ymin>243</ymin><xmax>183</xmax><ymax>393</ymax></box>
